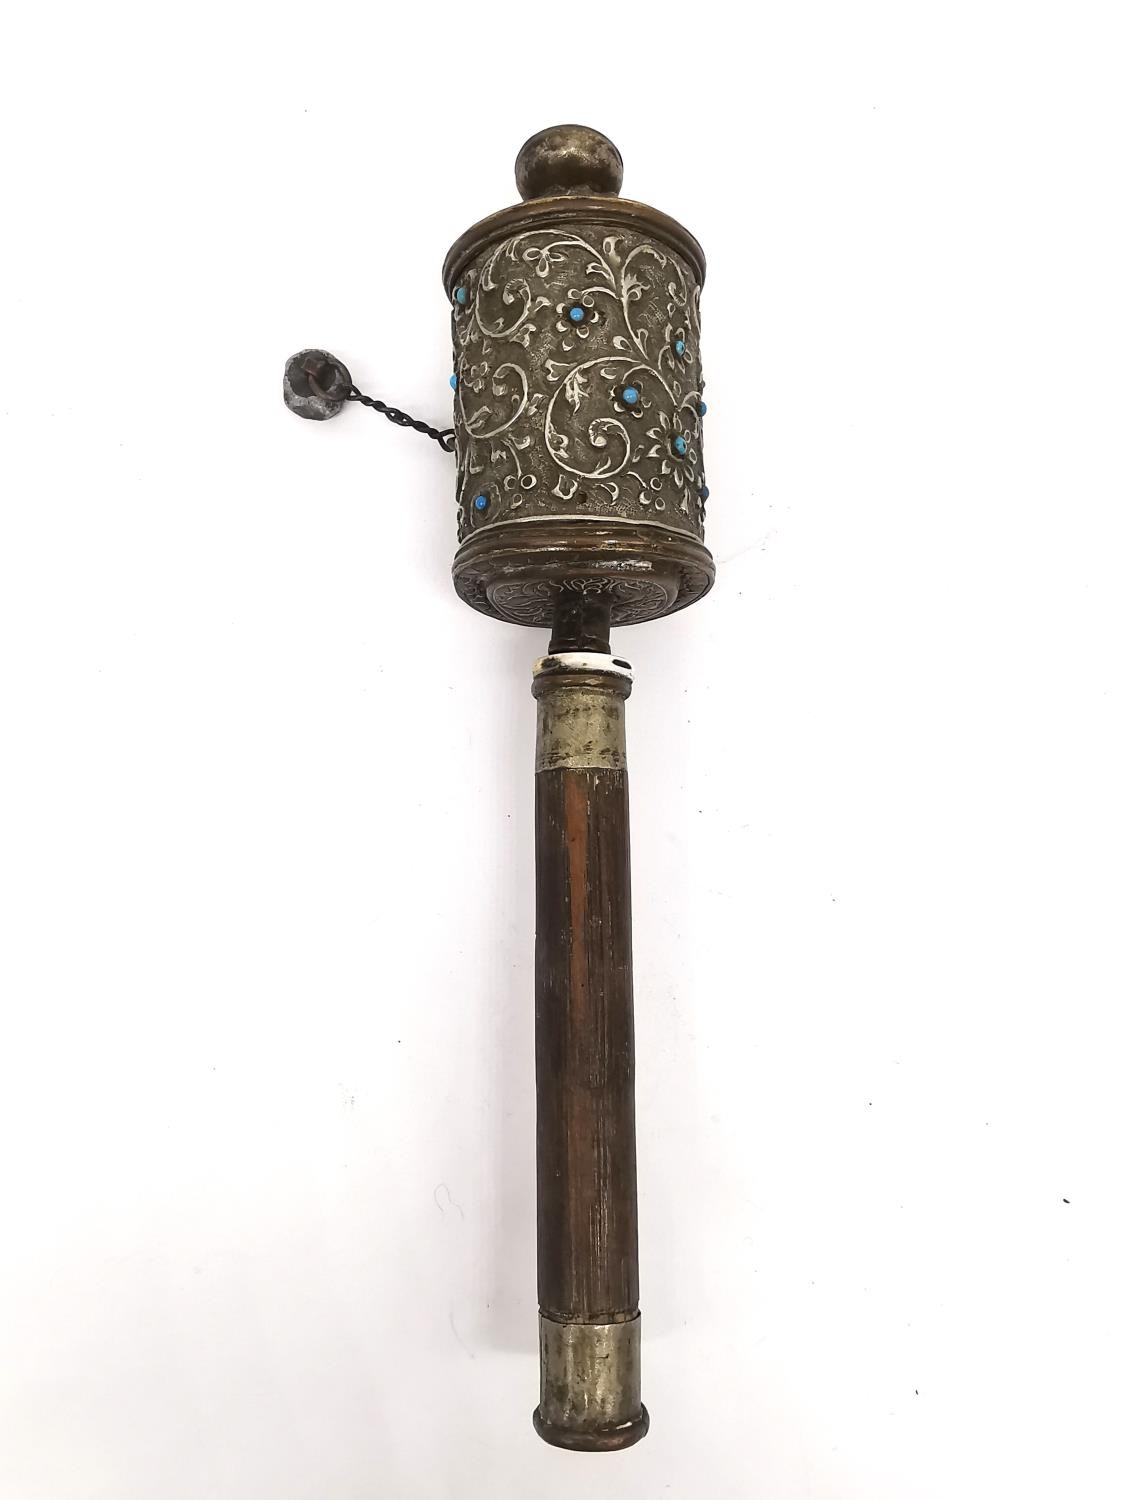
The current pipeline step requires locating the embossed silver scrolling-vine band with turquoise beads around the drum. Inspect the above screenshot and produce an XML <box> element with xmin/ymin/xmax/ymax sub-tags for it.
<box><xmin>453</xmin><ymin>230</ymin><xmax>707</xmax><ymax>540</ymax></box>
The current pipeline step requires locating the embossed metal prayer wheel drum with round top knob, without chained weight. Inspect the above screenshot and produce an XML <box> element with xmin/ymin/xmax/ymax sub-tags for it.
<box><xmin>443</xmin><ymin>125</ymin><xmax>714</xmax><ymax>627</ymax></box>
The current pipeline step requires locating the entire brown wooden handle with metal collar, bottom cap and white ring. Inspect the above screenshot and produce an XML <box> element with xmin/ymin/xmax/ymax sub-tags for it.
<box><xmin>533</xmin><ymin>651</ymin><xmax>648</xmax><ymax>1449</ymax></box>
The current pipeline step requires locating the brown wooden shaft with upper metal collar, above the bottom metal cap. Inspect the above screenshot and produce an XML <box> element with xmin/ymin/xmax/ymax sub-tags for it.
<box><xmin>536</xmin><ymin>659</ymin><xmax>639</xmax><ymax>1323</ymax></box>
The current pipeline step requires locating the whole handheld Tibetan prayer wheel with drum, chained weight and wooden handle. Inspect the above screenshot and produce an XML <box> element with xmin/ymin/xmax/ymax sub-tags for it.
<box><xmin>287</xmin><ymin>126</ymin><xmax>714</xmax><ymax>1451</ymax></box>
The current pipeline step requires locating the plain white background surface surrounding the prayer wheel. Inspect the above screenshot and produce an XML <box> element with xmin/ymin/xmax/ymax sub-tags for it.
<box><xmin>0</xmin><ymin>0</ymin><xmax>1125</xmax><ymax>1500</ymax></box>
